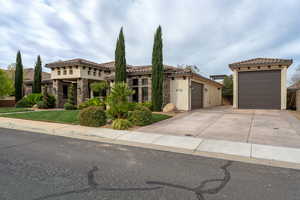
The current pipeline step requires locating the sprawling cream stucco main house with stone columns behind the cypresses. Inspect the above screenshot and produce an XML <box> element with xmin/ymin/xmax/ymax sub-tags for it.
<box><xmin>46</xmin><ymin>59</ymin><xmax>222</xmax><ymax>110</ymax></box>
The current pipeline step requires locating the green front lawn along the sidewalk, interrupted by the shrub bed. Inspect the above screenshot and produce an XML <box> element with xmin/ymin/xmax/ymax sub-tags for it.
<box><xmin>1</xmin><ymin>110</ymin><xmax>171</xmax><ymax>124</ymax></box>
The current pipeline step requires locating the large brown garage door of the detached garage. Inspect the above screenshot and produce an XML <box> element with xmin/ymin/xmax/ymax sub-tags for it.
<box><xmin>238</xmin><ymin>70</ymin><xmax>281</xmax><ymax>109</ymax></box>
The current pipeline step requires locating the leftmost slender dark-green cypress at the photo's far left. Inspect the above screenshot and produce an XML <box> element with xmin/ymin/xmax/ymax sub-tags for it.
<box><xmin>15</xmin><ymin>51</ymin><xmax>23</xmax><ymax>101</ymax></box>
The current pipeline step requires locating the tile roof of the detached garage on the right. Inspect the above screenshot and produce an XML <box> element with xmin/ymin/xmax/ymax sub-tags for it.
<box><xmin>229</xmin><ymin>58</ymin><xmax>293</xmax><ymax>69</ymax></box>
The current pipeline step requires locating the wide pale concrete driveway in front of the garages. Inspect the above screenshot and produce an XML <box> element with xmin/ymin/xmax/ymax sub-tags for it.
<box><xmin>138</xmin><ymin>106</ymin><xmax>300</xmax><ymax>148</ymax></box>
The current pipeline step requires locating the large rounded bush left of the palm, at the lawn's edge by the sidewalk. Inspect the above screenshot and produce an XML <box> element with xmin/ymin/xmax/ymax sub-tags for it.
<box><xmin>79</xmin><ymin>106</ymin><xmax>106</xmax><ymax>127</ymax></box>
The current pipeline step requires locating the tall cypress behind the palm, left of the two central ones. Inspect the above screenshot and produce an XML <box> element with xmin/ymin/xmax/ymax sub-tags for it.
<box><xmin>115</xmin><ymin>27</ymin><xmax>127</xmax><ymax>82</ymax></box>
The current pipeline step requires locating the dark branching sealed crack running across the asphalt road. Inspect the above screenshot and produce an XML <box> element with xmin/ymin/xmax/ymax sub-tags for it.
<box><xmin>33</xmin><ymin>161</ymin><xmax>233</xmax><ymax>200</ymax></box>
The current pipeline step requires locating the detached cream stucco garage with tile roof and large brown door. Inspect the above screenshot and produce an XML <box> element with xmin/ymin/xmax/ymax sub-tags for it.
<box><xmin>229</xmin><ymin>58</ymin><xmax>293</xmax><ymax>109</ymax></box>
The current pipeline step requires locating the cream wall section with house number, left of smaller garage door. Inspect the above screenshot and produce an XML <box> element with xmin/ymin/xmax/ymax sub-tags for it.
<box><xmin>170</xmin><ymin>78</ymin><xmax>190</xmax><ymax>110</ymax></box>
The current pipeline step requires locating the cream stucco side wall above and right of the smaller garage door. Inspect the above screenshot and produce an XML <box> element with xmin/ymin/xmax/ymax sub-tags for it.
<box><xmin>190</xmin><ymin>79</ymin><xmax>222</xmax><ymax>108</ymax></box>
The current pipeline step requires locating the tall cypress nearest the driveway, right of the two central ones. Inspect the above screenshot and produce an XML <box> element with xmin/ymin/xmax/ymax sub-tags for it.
<box><xmin>152</xmin><ymin>26</ymin><xmax>164</xmax><ymax>111</ymax></box>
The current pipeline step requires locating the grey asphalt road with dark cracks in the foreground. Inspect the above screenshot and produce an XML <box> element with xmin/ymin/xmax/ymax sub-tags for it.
<box><xmin>0</xmin><ymin>128</ymin><xmax>300</xmax><ymax>200</ymax></box>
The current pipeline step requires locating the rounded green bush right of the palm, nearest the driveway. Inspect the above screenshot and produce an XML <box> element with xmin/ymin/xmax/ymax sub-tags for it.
<box><xmin>129</xmin><ymin>106</ymin><xmax>152</xmax><ymax>126</ymax></box>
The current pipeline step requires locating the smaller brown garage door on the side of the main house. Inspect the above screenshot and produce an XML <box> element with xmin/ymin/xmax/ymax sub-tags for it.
<box><xmin>191</xmin><ymin>81</ymin><xmax>203</xmax><ymax>109</ymax></box>
